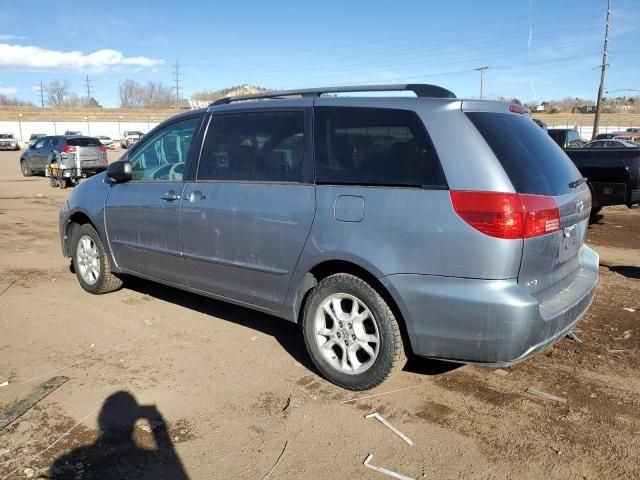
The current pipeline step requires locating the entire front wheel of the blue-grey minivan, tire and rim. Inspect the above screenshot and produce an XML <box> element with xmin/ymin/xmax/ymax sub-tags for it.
<box><xmin>71</xmin><ymin>224</ymin><xmax>122</xmax><ymax>295</ymax></box>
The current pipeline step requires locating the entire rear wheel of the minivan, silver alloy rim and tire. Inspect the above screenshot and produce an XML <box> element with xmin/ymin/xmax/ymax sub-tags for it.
<box><xmin>303</xmin><ymin>273</ymin><xmax>406</xmax><ymax>390</ymax></box>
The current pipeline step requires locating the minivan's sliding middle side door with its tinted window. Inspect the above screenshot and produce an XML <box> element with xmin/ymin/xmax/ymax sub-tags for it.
<box><xmin>182</xmin><ymin>108</ymin><xmax>315</xmax><ymax>310</ymax></box>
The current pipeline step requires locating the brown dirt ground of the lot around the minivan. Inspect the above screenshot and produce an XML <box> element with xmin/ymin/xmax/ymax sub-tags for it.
<box><xmin>0</xmin><ymin>148</ymin><xmax>640</xmax><ymax>480</ymax></box>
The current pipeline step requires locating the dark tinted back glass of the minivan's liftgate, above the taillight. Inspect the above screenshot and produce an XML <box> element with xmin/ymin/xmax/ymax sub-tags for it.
<box><xmin>467</xmin><ymin>112</ymin><xmax>582</xmax><ymax>196</ymax></box>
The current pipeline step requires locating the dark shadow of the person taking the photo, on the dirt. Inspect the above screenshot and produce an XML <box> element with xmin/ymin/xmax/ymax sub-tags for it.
<box><xmin>49</xmin><ymin>392</ymin><xmax>189</xmax><ymax>480</ymax></box>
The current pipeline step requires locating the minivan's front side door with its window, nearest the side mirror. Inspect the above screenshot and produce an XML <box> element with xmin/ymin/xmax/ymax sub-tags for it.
<box><xmin>105</xmin><ymin>114</ymin><xmax>202</xmax><ymax>284</ymax></box>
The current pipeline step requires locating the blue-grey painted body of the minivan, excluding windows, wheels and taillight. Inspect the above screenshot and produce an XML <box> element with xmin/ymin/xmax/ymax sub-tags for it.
<box><xmin>61</xmin><ymin>97</ymin><xmax>598</xmax><ymax>365</ymax></box>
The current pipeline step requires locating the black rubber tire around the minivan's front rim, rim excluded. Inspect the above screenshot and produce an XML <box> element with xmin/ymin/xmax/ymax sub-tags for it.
<box><xmin>71</xmin><ymin>224</ymin><xmax>122</xmax><ymax>295</ymax></box>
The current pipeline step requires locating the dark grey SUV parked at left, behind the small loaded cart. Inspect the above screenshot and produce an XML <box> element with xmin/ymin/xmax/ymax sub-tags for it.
<box><xmin>20</xmin><ymin>135</ymin><xmax>107</xmax><ymax>177</ymax></box>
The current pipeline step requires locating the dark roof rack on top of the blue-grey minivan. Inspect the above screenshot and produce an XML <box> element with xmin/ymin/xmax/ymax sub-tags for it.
<box><xmin>209</xmin><ymin>83</ymin><xmax>456</xmax><ymax>107</ymax></box>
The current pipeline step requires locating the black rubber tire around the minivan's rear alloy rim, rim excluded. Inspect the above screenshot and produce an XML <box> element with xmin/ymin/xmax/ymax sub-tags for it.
<box><xmin>302</xmin><ymin>273</ymin><xmax>407</xmax><ymax>390</ymax></box>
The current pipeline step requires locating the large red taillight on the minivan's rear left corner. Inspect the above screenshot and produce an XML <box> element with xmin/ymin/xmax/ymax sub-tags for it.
<box><xmin>451</xmin><ymin>191</ymin><xmax>560</xmax><ymax>239</ymax></box>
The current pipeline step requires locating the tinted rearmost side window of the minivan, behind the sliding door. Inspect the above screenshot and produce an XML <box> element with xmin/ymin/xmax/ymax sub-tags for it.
<box><xmin>315</xmin><ymin>107</ymin><xmax>446</xmax><ymax>188</ymax></box>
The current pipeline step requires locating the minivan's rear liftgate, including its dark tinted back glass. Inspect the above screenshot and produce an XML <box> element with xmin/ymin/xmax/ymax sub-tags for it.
<box><xmin>463</xmin><ymin>107</ymin><xmax>591</xmax><ymax>306</ymax></box>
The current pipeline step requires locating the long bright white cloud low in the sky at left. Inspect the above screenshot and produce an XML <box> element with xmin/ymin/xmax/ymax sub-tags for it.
<box><xmin>0</xmin><ymin>43</ymin><xmax>164</xmax><ymax>71</ymax></box>
